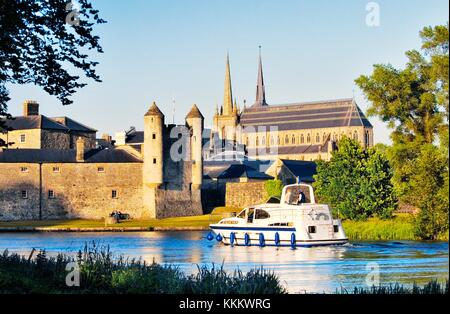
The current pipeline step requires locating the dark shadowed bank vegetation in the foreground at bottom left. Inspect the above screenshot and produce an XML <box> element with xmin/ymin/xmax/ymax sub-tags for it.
<box><xmin>0</xmin><ymin>244</ymin><xmax>286</xmax><ymax>294</ymax></box>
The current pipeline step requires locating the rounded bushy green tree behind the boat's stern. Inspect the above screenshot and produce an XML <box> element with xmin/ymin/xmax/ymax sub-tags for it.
<box><xmin>314</xmin><ymin>137</ymin><xmax>397</xmax><ymax>220</ymax></box>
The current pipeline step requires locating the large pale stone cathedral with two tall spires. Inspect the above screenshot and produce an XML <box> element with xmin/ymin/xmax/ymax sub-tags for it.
<box><xmin>209</xmin><ymin>53</ymin><xmax>373</xmax><ymax>161</ymax></box>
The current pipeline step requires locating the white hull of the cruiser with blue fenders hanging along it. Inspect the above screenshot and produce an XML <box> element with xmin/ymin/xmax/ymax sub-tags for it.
<box><xmin>210</xmin><ymin>225</ymin><xmax>348</xmax><ymax>247</ymax></box>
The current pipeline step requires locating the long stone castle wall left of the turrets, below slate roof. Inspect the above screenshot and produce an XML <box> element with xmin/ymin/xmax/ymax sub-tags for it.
<box><xmin>0</xmin><ymin>163</ymin><xmax>144</xmax><ymax>220</ymax></box>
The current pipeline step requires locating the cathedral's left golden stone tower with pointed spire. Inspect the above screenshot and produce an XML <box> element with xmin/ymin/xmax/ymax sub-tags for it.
<box><xmin>212</xmin><ymin>54</ymin><xmax>239</xmax><ymax>148</ymax></box>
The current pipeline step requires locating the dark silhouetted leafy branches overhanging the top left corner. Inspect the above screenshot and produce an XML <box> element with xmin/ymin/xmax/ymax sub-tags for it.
<box><xmin>0</xmin><ymin>0</ymin><xmax>105</xmax><ymax>131</ymax></box>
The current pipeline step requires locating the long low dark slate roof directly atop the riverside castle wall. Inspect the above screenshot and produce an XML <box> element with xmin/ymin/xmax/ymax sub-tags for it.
<box><xmin>0</xmin><ymin>149</ymin><xmax>142</xmax><ymax>163</ymax></box>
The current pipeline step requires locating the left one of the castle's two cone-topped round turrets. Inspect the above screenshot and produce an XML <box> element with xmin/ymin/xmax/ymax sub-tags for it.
<box><xmin>142</xmin><ymin>102</ymin><xmax>164</xmax><ymax>217</ymax></box>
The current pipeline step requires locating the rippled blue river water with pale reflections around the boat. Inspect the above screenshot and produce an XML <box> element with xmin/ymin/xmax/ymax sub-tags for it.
<box><xmin>0</xmin><ymin>232</ymin><xmax>449</xmax><ymax>293</ymax></box>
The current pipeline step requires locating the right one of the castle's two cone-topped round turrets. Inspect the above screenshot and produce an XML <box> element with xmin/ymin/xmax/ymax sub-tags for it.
<box><xmin>186</xmin><ymin>105</ymin><xmax>204</xmax><ymax>189</ymax></box>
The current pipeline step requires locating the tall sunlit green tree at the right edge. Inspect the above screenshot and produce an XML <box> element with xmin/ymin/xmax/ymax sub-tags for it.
<box><xmin>356</xmin><ymin>23</ymin><xmax>449</xmax><ymax>239</ymax></box>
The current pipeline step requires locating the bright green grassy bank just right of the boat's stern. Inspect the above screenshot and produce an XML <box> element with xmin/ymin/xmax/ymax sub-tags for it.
<box><xmin>342</xmin><ymin>214</ymin><xmax>448</xmax><ymax>240</ymax></box>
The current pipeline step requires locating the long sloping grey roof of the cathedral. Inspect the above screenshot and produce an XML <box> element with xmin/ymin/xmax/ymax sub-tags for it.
<box><xmin>240</xmin><ymin>98</ymin><xmax>372</xmax><ymax>133</ymax></box>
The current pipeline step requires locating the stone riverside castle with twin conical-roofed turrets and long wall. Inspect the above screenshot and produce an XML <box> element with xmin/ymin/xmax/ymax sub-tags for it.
<box><xmin>0</xmin><ymin>103</ymin><xmax>203</xmax><ymax>220</ymax></box>
